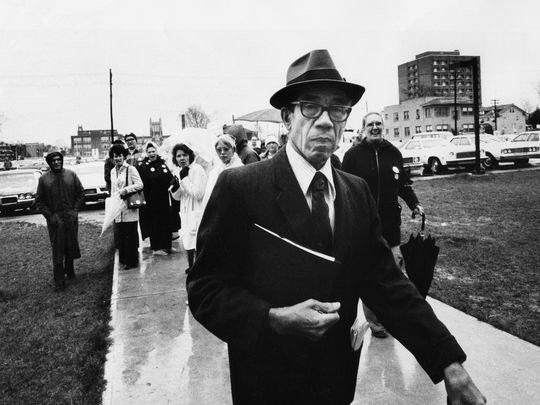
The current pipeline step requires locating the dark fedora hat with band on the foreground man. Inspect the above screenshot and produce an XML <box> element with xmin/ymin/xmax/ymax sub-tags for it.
<box><xmin>270</xmin><ymin>49</ymin><xmax>366</xmax><ymax>109</ymax></box>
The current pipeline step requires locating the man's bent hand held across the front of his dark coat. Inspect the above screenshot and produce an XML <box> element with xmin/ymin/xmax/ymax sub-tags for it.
<box><xmin>269</xmin><ymin>299</ymin><xmax>341</xmax><ymax>340</ymax></box>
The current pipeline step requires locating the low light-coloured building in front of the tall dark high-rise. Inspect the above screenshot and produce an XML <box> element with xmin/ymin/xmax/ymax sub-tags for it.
<box><xmin>382</xmin><ymin>97</ymin><xmax>474</xmax><ymax>140</ymax></box>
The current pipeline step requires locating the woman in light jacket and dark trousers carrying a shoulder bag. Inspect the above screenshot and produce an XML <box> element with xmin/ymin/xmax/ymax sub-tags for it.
<box><xmin>109</xmin><ymin>145</ymin><xmax>143</xmax><ymax>269</ymax></box>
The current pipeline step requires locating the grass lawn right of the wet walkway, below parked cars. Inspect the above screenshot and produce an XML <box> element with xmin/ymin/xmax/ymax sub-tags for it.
<box><xmin>402</xmin><ymin>170</ymin><xmax>540</xmax><ymax>345</ymax></box>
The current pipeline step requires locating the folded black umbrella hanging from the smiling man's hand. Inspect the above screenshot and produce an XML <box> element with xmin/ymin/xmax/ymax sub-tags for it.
<box><xmin>400</xmin><ymin>214</ymin><xmax>439</xmax><ymax>298</ymax></box>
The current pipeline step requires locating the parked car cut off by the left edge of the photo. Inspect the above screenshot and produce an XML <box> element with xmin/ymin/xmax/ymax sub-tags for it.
<box><xmin>0</xmin><ymin>169</ymin><xmax>42</xmax><ymax>214</ymax></box>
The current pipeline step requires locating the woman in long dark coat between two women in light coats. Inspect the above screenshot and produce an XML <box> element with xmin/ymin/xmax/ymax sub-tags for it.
<box><xmin>138</xmin><ymin>142</ymin><xmax>173</xmax><ymax>256</ymax></box>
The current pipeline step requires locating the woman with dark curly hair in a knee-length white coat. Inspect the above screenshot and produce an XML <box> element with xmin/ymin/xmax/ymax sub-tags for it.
<box><xmin>171</xmin><ymin>143</ymin><xmax>207</xmax><ymax>273</ymax></box>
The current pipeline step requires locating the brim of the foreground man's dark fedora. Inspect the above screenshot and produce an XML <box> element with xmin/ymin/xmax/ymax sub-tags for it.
<box><xmin>270</xmin><ymin>79</ymin><xmax>366</xmax><ymax>110</ymax></box>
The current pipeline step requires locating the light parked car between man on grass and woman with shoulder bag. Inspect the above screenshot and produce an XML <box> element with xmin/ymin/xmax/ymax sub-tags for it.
<box><xmin>68</xmin><ymin>161</ymin><xmax>109</xmax><ymax>205</ymax></box>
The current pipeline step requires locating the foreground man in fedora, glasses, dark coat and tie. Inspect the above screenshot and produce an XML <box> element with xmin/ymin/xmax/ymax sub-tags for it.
<box><xmin>187</xmin><ymin>50</ymin><xmax>485</xmax><ymax>404</ymax></box>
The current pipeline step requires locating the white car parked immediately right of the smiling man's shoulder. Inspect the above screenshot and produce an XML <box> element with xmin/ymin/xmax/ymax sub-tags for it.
<box><xmin>402</xmin><ymin>137</ymin><xmax>486</xmax><ymax>173</ymax></box>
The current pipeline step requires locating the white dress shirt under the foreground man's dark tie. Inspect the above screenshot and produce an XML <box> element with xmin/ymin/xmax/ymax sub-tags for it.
<box><xmin>285</xmin><ymin>142</ymin><xmax>336</xmax><ymax>232</ymax></box>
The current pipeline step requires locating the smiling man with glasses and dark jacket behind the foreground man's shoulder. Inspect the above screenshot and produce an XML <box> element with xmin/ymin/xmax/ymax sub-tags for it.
<box><xmin>341</xmin><ymin>112</ymin><xmax>424</xmax><ymax>338</ymax></box>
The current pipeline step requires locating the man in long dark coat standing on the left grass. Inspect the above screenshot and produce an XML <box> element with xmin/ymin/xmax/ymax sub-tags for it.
<box><xmin>36</xmin><ymin>152</ymin><xmax>84</xmax><ymax>291</ymax></box>
